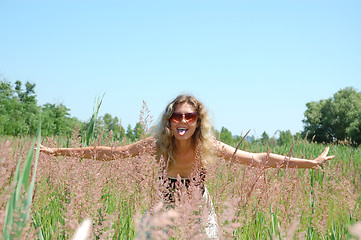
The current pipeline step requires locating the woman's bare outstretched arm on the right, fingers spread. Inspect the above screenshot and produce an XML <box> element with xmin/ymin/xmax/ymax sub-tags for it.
<box><xmin>217</xmin><ymin>141</ymin><xmax>335</xmax><ymax>168</ymax></box>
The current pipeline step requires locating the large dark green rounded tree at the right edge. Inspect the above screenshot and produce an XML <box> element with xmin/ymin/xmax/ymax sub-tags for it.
<box><xmin>302</xmin><ymin>87</ymin><xmax>361</xmax><ymax>144</ymax></box>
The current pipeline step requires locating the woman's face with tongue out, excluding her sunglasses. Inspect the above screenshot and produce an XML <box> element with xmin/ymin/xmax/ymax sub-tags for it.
<box><xmin>171</xmin><ymin>102</ymin><xmax>198</xmax><ymax>141</ymax></box>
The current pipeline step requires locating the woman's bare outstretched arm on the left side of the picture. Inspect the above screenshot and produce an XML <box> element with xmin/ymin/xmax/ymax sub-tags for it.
<box><xmin>40</xmin><ymin>137</ymin><xmax>154</xmax><ymax>161</ymax></box>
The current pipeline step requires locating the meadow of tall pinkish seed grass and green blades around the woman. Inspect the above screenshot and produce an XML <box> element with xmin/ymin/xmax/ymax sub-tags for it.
<box><xmin>0</xmin><ymin>131</ymin><xmax>361</xmax><ymax>239</ymax></box>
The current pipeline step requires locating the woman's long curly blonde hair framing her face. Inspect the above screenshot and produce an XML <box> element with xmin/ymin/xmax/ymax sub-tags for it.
<box><xmin>155</xmin><ymin>94</ymin><xmax>215</xmax><ymax>167</ymax></box>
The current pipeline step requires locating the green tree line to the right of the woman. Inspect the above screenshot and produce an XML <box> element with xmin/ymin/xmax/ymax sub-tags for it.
<box><xmin>219</xmin><ymin>87</ymin><xmax>361</xmax><ymax>146</ymax></box>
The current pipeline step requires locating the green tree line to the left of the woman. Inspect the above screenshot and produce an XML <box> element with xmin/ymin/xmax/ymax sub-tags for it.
<box><xmin>0</xmin><ymin>80</ymin><xmax>143</xmax><ymax>142</ymax></box>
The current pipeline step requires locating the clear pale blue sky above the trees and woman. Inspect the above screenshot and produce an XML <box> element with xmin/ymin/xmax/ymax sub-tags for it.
<box><xmin>0</xmin><ymin>0</ymin><xmax>361</xmax><ymax>136</ymax></box>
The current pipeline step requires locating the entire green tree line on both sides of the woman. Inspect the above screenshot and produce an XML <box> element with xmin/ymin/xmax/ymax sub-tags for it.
<box><xmin>0</xmin><ymin>80</ymin><xmax>361</xmax><ymax>146</ymax></box>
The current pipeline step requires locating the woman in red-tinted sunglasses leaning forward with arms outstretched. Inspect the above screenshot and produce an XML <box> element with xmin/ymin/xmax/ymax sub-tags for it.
<box><xmin>40</xmin><ymin>95</ymin><xmax>334</xmax><ymax>238</ymax></box>
